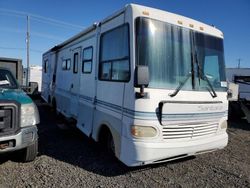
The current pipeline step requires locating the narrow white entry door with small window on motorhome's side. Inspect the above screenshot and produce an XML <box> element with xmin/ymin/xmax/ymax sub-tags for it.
<box><xmin>70</xmin><ymin>47</ymin><xmax>82</xmax><ymax>118</ymax></box>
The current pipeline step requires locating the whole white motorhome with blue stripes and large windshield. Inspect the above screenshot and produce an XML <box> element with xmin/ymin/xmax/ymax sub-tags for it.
<box><xmin>41</xmin><ymin>4</ymin><xmax>228</xmax><ymax>166</ymax></box>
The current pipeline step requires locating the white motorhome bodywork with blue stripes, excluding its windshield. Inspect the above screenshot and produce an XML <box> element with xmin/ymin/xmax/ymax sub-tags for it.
<box><xmin>42</xmin><ymin>4</ymin><xmax>228</xmax><ymax>166</ymax></box>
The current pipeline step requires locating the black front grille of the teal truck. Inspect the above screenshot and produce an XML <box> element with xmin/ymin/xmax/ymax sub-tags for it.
<box><xmin>0</xmin><ymin>101</ymin><xmax>19</xmax><ymax>136</ymax></box>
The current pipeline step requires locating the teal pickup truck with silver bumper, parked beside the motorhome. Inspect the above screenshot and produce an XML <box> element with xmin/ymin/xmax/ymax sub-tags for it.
<box><xmin>0</xmin><ymin>68</ymin><xmax>39</xmax><ymax>162</ymax></box>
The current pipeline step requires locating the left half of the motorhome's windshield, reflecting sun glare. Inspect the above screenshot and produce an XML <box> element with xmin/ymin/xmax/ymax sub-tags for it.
<box><xmin>136</xmin><ymin>18</ymin><xmax>192</xmax><ymax>89</ymax></box>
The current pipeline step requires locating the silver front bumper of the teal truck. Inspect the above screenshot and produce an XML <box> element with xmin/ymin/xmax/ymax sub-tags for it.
<box><xmin>0</xmin><ymin>126</ymin><xmax>38</xmax><ymax>154</ymax></box>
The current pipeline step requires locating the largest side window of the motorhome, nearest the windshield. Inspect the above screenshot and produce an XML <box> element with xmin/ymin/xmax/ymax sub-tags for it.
<box><xmin>99</xmin><ymin>24</ymin><xmax>130</xmax><ymax>82</ymax></box>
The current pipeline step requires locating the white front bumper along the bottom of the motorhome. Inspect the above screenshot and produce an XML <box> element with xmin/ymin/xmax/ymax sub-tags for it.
<box><xmin>120</xmin><ymin>132</ymin><xmax>228</xmax><ymax>166</ymax></box>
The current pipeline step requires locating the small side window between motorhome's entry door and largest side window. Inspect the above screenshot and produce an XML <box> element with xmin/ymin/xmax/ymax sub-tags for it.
<box><xmin>82</xmin><ymin>46</ymin><xmax>93</xmax><ymax>73</ymax></box>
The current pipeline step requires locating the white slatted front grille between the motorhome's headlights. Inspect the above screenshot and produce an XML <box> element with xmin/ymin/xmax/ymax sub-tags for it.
<box><xmin>162</xmin><ymin>122</ymin><xmax>218</xmax><ymax>140</ymax></box>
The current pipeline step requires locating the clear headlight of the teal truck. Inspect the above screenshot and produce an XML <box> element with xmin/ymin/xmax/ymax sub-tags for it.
<box><xmin>21</xmin><ymin>103</ymin><xmax>40</xmax><ymax>127</ymax></box>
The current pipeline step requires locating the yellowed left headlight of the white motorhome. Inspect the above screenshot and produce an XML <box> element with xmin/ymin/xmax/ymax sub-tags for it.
<box><xmin>131</xmin><ymin>125</ymin><xmax>157</xmax><ymax>138</ymax></box>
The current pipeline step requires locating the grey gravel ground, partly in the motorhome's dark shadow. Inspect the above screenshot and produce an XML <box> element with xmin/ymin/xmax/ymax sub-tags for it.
<box><xmin>0</xmin><ymin>101</ymin><xmax>250</xmax><ymax>188</ymax></box>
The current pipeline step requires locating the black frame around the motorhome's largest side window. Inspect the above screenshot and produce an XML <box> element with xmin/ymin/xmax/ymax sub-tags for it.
<box><xmin>98</xmin><ymin>23</ymin><xmax>131</xmax><ymax>83</ymax></box>
